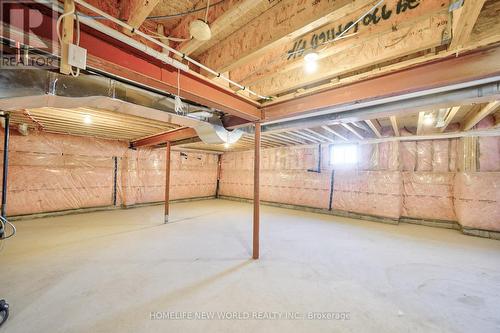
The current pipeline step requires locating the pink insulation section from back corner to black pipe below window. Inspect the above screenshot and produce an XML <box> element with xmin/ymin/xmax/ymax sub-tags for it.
<box><xmin>220</xmin><ymin>146</ymin><xmax>330</xmax><ymax>208</ymax></box>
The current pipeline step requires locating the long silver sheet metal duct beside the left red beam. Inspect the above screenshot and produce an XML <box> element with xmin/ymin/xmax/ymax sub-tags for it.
<box><xmin>0</xmin><ymin>69</ymin><xmax>243</xmax><ymax>144</ymax></box>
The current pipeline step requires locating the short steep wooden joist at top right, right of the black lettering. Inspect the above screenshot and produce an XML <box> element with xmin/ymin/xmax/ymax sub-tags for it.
<box><xmin>450</xmin><ymin>0</ymin><xmax>486</xmax><ymax>49</ymax></box>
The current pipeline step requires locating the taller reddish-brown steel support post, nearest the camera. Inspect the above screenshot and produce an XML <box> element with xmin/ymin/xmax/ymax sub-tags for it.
<box><xmin>252</xmin><ymin>123</ymin><xmax>260</xmax><ymax>259</ymax></box>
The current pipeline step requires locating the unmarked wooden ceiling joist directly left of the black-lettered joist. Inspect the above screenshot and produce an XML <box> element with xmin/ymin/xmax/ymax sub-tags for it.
<box><xmin>199</xmin><ymin>0</ymin><xmax>372</xmax><ymax>72</ymax></box>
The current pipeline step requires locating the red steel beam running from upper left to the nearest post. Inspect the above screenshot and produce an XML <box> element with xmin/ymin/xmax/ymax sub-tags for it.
<box><xmin>2</xmin><ymin>5</ymin><xmax>262</xmax><ymax>121</ymax></box>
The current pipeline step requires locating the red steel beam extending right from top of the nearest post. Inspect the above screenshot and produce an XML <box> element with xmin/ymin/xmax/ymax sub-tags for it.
<box><xmin>263</xmin><ymin>47</ymin><xmax>500</xmax><ymax>121</ymax></box>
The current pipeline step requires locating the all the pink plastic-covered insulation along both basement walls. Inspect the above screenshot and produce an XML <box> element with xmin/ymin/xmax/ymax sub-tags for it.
<box><xmin>1</xmin><ymin>128</ymin><xmax>500</xmax><ymax>231</ymax></box>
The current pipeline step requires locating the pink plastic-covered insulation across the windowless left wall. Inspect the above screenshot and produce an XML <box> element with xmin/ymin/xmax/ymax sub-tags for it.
<box><xmin>2</xmin><ymin>131</ymin><xmax>217</xmax><ymax>216</ymax></box>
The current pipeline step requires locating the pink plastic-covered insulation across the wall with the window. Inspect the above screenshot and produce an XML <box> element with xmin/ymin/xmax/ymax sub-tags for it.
<box><xmin>220</xmin><ymin>132</ymin><xmax>500</xmax><ymax>231</ymax></box>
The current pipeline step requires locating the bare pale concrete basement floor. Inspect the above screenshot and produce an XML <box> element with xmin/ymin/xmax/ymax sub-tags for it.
<box><xmin>0</xmin><ymin>200</ymin><xmax>500</xmax><ymax>333</ymax></box>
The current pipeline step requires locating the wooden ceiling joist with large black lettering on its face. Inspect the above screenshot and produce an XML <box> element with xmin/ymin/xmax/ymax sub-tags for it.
<box><xmin>231</xmin><ymin>0</ymin><xmax>448</xmax><ymax>89</ymax></box>
